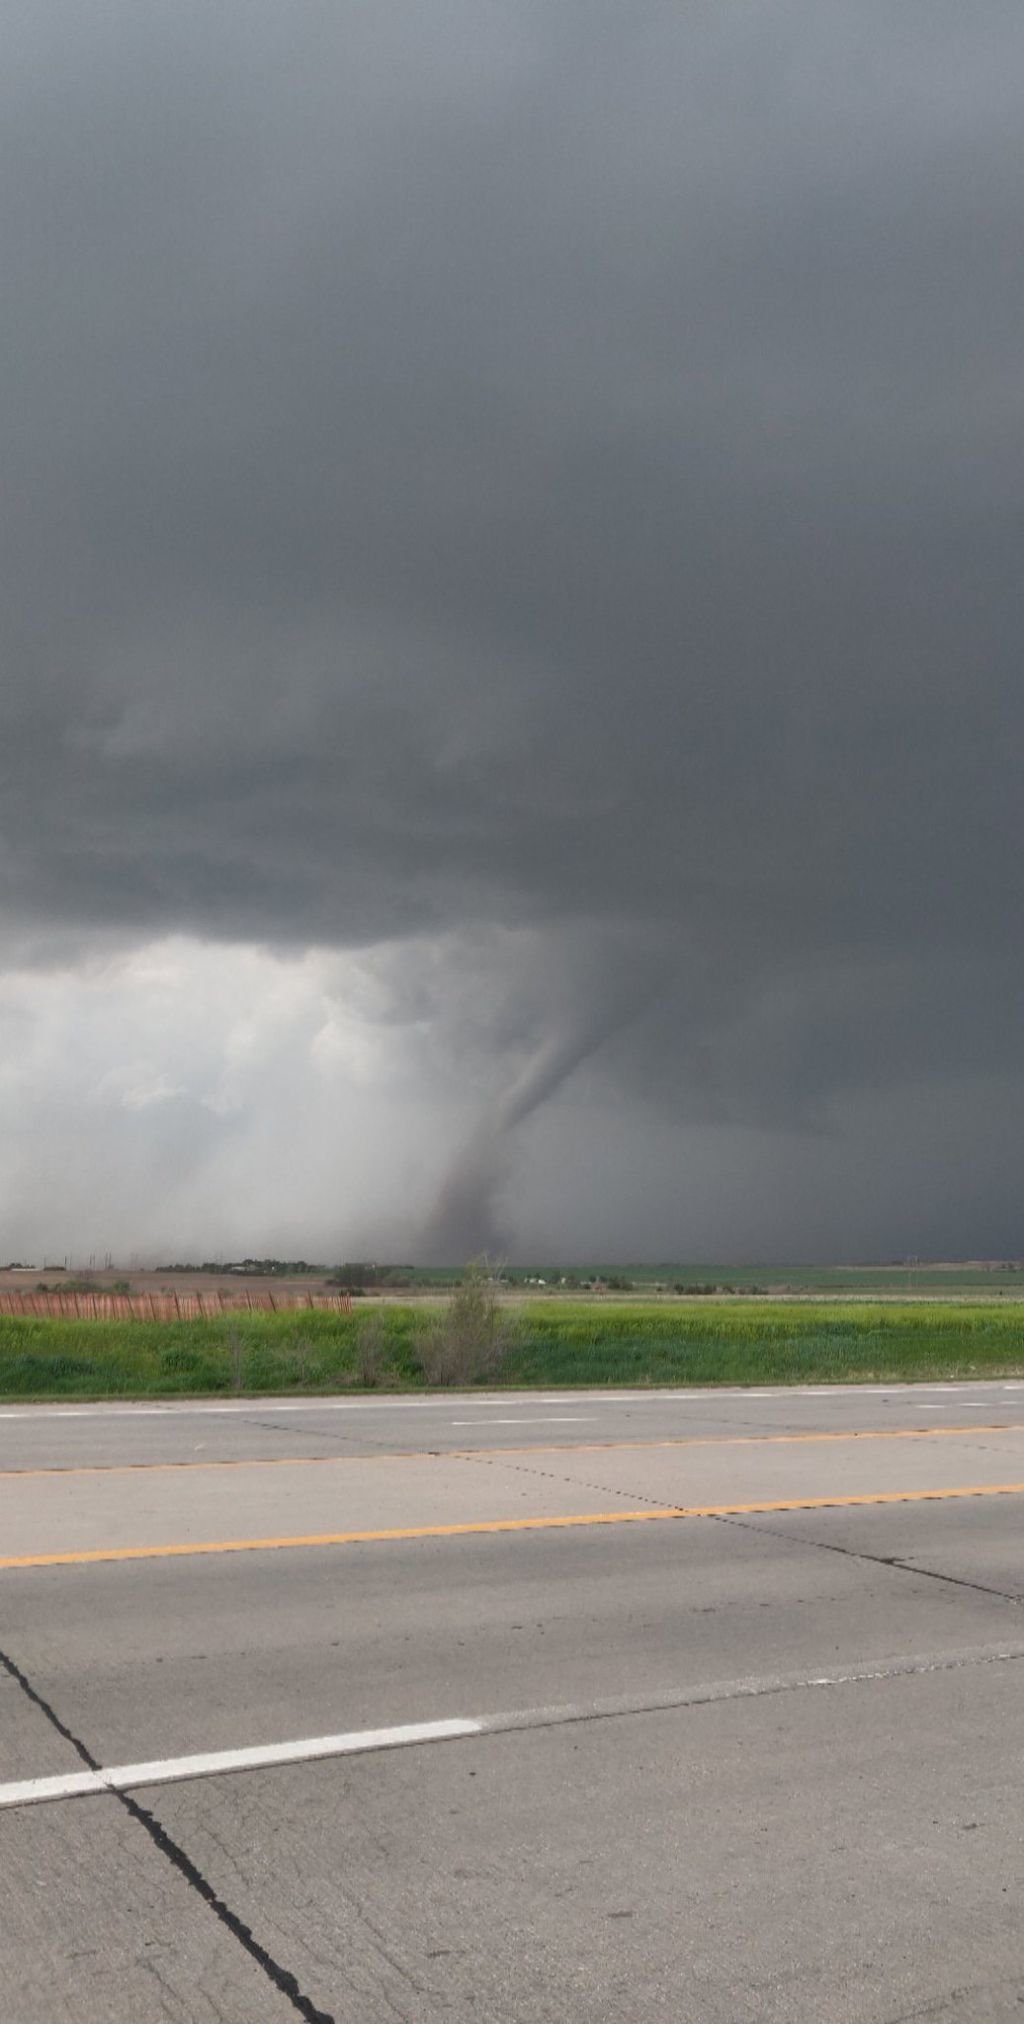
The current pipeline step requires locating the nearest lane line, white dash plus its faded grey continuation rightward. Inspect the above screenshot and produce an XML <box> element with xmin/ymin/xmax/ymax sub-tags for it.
<box><xmin>0</xmin><ymin>1643</ymin><xmax>1024</xmax><ymax>1809</ymax></box>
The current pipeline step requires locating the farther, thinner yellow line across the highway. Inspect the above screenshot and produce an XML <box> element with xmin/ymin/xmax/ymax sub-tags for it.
<box><xmin>8</xmin><ymin>1421</ymin><xmax>1024</xmax><ymax>1482</ymax></box>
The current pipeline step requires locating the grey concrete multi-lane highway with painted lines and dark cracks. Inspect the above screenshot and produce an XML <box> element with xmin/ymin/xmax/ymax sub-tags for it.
<box><xmin>0</xmin><ymin>1382</ymin><xmax>1024</xmax><ymax>2024</ymax></box>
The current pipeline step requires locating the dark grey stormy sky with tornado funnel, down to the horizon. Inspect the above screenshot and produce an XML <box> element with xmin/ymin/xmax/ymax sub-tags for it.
<box><xmin>0</xmin><ymin>0</ymin><xmax>1024</xmax><ymax>1259</ymax></box>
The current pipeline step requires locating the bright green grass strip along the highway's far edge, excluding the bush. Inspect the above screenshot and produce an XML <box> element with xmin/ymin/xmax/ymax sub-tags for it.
<box><xmin>0</xmin><ymin>1297</ymin><xmax>1024</xmax><ymax>1401</ymax></box>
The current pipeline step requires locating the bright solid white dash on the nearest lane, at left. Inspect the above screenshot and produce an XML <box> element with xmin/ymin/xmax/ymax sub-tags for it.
<box><xmin>0</xmin><ymin>1720</ymin><xmax>484</xmax><ymax>1807</ymax></box>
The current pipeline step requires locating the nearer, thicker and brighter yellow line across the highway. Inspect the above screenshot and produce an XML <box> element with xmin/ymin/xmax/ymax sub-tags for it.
<box><xmin>0</xmin><ymin>1484</ymin><xmax>1024</xmax><ymax>1569</ymax></box>
